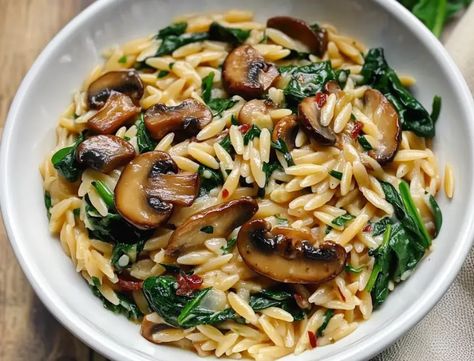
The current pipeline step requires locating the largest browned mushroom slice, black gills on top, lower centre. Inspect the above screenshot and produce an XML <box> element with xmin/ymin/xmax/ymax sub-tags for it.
<box><xmin>237</xmin><ymin>219</ymin><xmax>347</xmax><ymax>283</ymax></box>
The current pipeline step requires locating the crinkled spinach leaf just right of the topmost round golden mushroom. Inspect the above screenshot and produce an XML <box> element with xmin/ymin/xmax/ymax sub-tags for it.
<box><xmin>279</xmin><ymin>61</ymin><xmax>336</xmax><ymax>107</ymax></box>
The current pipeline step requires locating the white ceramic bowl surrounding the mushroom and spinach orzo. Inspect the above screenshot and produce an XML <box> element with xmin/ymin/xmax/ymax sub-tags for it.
<box><xmin>0</xmin><ymin>0</ymin><xmax>474</xmax><ymax>361</ymax></box>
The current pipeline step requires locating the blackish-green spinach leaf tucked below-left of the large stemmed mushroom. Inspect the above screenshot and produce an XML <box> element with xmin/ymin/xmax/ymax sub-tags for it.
<box><xmin>85</xmin><ymin>196</ymin><xmax>153</xmax><ymax>243</ymax></box>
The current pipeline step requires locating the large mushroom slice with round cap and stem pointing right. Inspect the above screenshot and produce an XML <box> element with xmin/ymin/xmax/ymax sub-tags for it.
<box><xmin>115</xmin><ymin>150</ymin><xmax>199</xmax><ymax>229</ymax></box>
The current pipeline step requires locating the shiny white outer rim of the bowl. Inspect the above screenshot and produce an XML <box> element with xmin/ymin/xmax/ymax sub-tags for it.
<box><xmin>0</xmin><ymin>0</ymin><xmax>474</xmax><ymax>361</ymax></box>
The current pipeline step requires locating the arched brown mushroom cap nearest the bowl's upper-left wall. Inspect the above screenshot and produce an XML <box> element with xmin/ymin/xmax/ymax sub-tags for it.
<box><xmin>87</xmin><ymin>70</ymin><xmax>143</xmax><ymax>109</ymax></box>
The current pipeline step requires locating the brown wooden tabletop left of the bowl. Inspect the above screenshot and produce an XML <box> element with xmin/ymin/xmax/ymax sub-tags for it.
<box><xmin>0</xmin><ymin>0</ymin><xmax>104</xmax><ymax>361</ymax></box>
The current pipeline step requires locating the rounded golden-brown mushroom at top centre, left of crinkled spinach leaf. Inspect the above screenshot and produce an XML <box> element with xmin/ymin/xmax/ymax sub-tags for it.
<box><xmin>222</xmin><ymin>45</ymin><xmax>279</xmax><ymax>99</ymax></box>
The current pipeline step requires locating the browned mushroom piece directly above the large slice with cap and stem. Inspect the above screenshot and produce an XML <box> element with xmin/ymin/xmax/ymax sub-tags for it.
<box><xmin>144</xmin><ymin>99</ymin><xmax>212</xmax><ymax>140</ymax></box>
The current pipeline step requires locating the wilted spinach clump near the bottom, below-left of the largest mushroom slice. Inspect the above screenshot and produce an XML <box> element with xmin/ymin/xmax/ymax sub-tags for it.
<box><xmin>143</xmin><ymin>276</ymin><xmax>237</xmax><ymax>328</ymax></box>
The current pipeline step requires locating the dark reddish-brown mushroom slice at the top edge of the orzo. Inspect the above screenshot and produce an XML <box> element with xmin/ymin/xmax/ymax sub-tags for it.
<box><xmin>267</xmin><ymin>16</ymin><xmax>328</xmax><ymax>56</ymax></box>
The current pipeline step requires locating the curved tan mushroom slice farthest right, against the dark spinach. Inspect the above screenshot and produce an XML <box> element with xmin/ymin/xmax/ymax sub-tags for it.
<box><xmin>364</xmin><ymin>89</ymin><xmax>401</xmax><ymax>164</ymax></box>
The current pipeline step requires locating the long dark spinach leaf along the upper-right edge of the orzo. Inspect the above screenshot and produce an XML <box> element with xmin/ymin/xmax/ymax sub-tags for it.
<box><xmin>361</xmin><ymin>48</ymin><xmax>435</xmax><ymax>138</ymax></box>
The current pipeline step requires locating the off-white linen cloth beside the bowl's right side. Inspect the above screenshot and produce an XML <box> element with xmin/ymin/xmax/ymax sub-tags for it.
<box><xmin>373</xmin><ymin>6</ymin><xmax>474</xmax><ymax>361</ymax></box>
